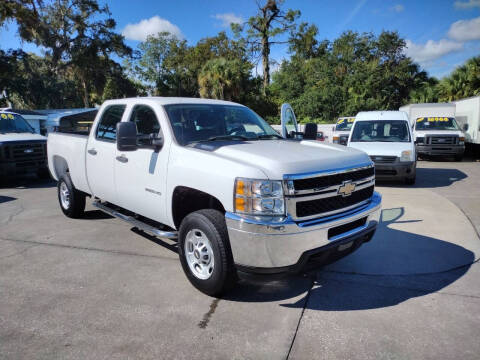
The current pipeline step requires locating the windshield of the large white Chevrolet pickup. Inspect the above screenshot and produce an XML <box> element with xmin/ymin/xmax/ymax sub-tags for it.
<box><xmin>165</xmin><ymin>104</ymin><xmax>282</xmax><ymax>145</ymax></box>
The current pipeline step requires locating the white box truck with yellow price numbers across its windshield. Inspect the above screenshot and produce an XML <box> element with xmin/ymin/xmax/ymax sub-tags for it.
<box><xmin>399</xmin><ymin>103</ymin><xmax>465</xmax><ymax>161</ymax></box>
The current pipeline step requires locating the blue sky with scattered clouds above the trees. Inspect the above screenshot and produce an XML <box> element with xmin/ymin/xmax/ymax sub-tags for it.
<box><xmin>0</xmin><ymin>0</ymin><xmax>480</xmax><ymax>77</ymax></box>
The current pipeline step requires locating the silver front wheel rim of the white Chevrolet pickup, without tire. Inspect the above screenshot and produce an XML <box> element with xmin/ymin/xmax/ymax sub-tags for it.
<box><xmin>184</xmin><ymin>229</ymin><xmax>215</xmax><ymax>280</ymax></box>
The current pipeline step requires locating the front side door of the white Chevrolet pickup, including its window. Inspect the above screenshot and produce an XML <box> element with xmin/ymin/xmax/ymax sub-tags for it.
<box><xmin>115</xmin><ymin>105</ymin><xmax>169</xmax><ymax>223</ymax></box>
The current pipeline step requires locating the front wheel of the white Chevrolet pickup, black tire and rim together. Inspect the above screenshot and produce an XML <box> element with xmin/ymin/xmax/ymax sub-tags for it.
<box><xmin>178</xmin><ymin>209</ymin><xmax>238</xmax><ymax>297</ymax></box>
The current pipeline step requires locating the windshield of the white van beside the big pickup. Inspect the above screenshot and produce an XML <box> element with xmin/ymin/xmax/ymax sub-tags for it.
<box><xmin>350</xmin><ymin>120</ymin><xmax>410</xmax><ymax>142</ymax></box>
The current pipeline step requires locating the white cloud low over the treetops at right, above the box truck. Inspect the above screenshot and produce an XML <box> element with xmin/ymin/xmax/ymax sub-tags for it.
<box><xmin>405</xmin><ymin>39</ymin><xmax>463</xmax><ymax>63</ymax></box>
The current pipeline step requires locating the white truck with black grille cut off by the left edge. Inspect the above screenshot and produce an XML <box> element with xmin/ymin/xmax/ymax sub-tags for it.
<box><xmin>0</xmin><ymin>111</ymin><xmax>49</xmax><ymax>179</ymax></box>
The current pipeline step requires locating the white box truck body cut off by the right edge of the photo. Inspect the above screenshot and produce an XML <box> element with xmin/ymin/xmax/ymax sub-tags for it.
<box><xmin>455</xmin><ymin>96</ymin><xmax>480</xmax><ymax>146</ymax></box>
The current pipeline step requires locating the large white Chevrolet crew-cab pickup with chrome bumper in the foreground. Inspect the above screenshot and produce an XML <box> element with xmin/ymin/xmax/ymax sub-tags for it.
<box><xmin>48</xmin><ymin>97</ymin><xmax>381</xmax><ymax>296</ymax></box>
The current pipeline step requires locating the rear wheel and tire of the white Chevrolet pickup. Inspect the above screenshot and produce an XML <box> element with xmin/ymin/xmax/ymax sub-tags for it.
<box><xmin>57</xmin><ymin>174</ymin><xmax>86</xmax><ymax>219</ymax></box>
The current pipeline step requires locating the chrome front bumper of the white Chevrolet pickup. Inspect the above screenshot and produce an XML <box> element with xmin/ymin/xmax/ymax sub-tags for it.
<box><xmin>225</xmin><ymin>192</ymin><xmax>382</xmax><ymax>269</ymax></box>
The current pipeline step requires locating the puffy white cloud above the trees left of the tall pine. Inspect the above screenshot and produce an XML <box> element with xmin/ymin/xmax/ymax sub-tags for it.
<box><xmin>122</xmin><ymin>16</ymin><xmax>183</xmax><ymax>41</ymax></box>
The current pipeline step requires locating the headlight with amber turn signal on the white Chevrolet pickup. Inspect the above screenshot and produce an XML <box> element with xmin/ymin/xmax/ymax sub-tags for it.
<box><xmin>234</xmin><ymin>178</ymin><xmax>285</xmax><ymax>215</ymax></box>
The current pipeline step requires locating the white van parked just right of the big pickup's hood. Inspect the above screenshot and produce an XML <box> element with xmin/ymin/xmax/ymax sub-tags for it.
<box><xmin>348</xmin><ymin>111</ymin><xmax>417</xmax><ymax>185</ymax></box>
